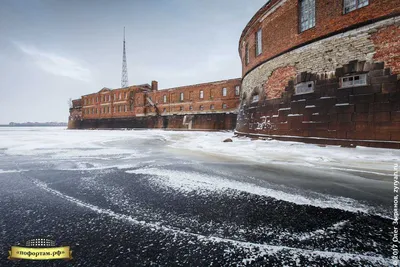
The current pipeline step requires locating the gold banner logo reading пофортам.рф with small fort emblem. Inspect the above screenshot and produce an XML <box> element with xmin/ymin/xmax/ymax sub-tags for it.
<box><xmin>8</xmin><ymin>238</ymin><xmax>72</xmax><ymax>260</ymax></box>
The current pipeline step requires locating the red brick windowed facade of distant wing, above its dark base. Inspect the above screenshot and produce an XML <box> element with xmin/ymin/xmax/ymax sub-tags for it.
<box><xmin>76</xmin><ymin>78</ymin><xmax>241</xmax><ymax>119</ymax></box>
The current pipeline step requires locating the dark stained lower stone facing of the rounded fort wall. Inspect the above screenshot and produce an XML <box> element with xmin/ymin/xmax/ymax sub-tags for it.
<box><xmin>236</xmin><ymin>61</ymin><xmax>400</xmax><ymax>148</ymax></box>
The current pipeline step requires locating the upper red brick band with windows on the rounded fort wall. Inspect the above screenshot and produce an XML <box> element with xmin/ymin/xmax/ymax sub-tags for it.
<box><xmin>239</xmin><ymin>0</ymin><xmax>400</xmax><ymax>76</ymax></box>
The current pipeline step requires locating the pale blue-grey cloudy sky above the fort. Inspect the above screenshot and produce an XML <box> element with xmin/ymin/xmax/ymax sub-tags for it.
<box><xmin>0</xmin><ymin>0</ymin><xmax>265</xmax><ymax>124</ymax></box>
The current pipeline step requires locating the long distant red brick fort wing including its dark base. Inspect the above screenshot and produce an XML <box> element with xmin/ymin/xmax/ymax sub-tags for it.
<box><xmin>70</xmin><ymin>79</ymin><xmax>241</xmax><ymax>130</ymax></box>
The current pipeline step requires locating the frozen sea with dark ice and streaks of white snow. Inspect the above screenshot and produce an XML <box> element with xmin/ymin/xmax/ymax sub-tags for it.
<box><xmin>0</xmin><ymin>127</ymin><xmax>400</xmax><ymax>266</ymax></box>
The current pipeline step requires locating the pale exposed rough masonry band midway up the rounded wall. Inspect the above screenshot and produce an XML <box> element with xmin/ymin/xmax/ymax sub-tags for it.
<box><xmin>242</xmin><ymin>17</ymin><xmax>400</xmax><ymax>102</ymax></box>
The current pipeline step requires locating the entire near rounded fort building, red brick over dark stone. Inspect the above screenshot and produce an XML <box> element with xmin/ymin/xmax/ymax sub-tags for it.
<box><xmin>236</xmin><ymin>0</ymin><xmax>400</xmax><ymax>148</ymax></box>
